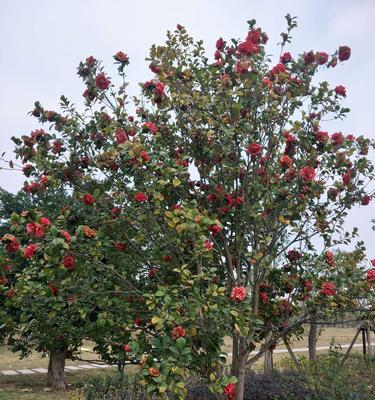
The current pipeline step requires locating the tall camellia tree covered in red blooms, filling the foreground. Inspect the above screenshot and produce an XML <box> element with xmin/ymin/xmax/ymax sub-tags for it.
<box><xmin>3</xmin><ymin>15</ymin><xmax>373</xmax><ymax>400</ymax></box>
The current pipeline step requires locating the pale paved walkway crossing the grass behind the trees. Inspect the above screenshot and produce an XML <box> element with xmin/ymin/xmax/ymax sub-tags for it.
<box><xmin>0</xmin><ymin>343</ymin><xmax>374</xmax><ymax>376</ymax></box>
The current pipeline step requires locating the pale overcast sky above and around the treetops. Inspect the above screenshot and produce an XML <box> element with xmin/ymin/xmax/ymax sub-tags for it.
<box><xmin>0</xmin><ymin>0</ymin><xmax>375</xmax><ymax>253</ymax></box>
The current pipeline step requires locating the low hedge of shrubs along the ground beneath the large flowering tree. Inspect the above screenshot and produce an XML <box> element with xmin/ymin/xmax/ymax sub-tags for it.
<box><xmin>82</xmin><ymin>352</ymin><xmax>375</xmax><ymax>400</ymax></box>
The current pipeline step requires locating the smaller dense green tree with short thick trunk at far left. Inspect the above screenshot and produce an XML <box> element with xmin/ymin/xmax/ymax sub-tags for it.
<box><xmin>0</xmin><ymin>189</ymin><xmax>106</xmax><ymax>389</ymax></box>
